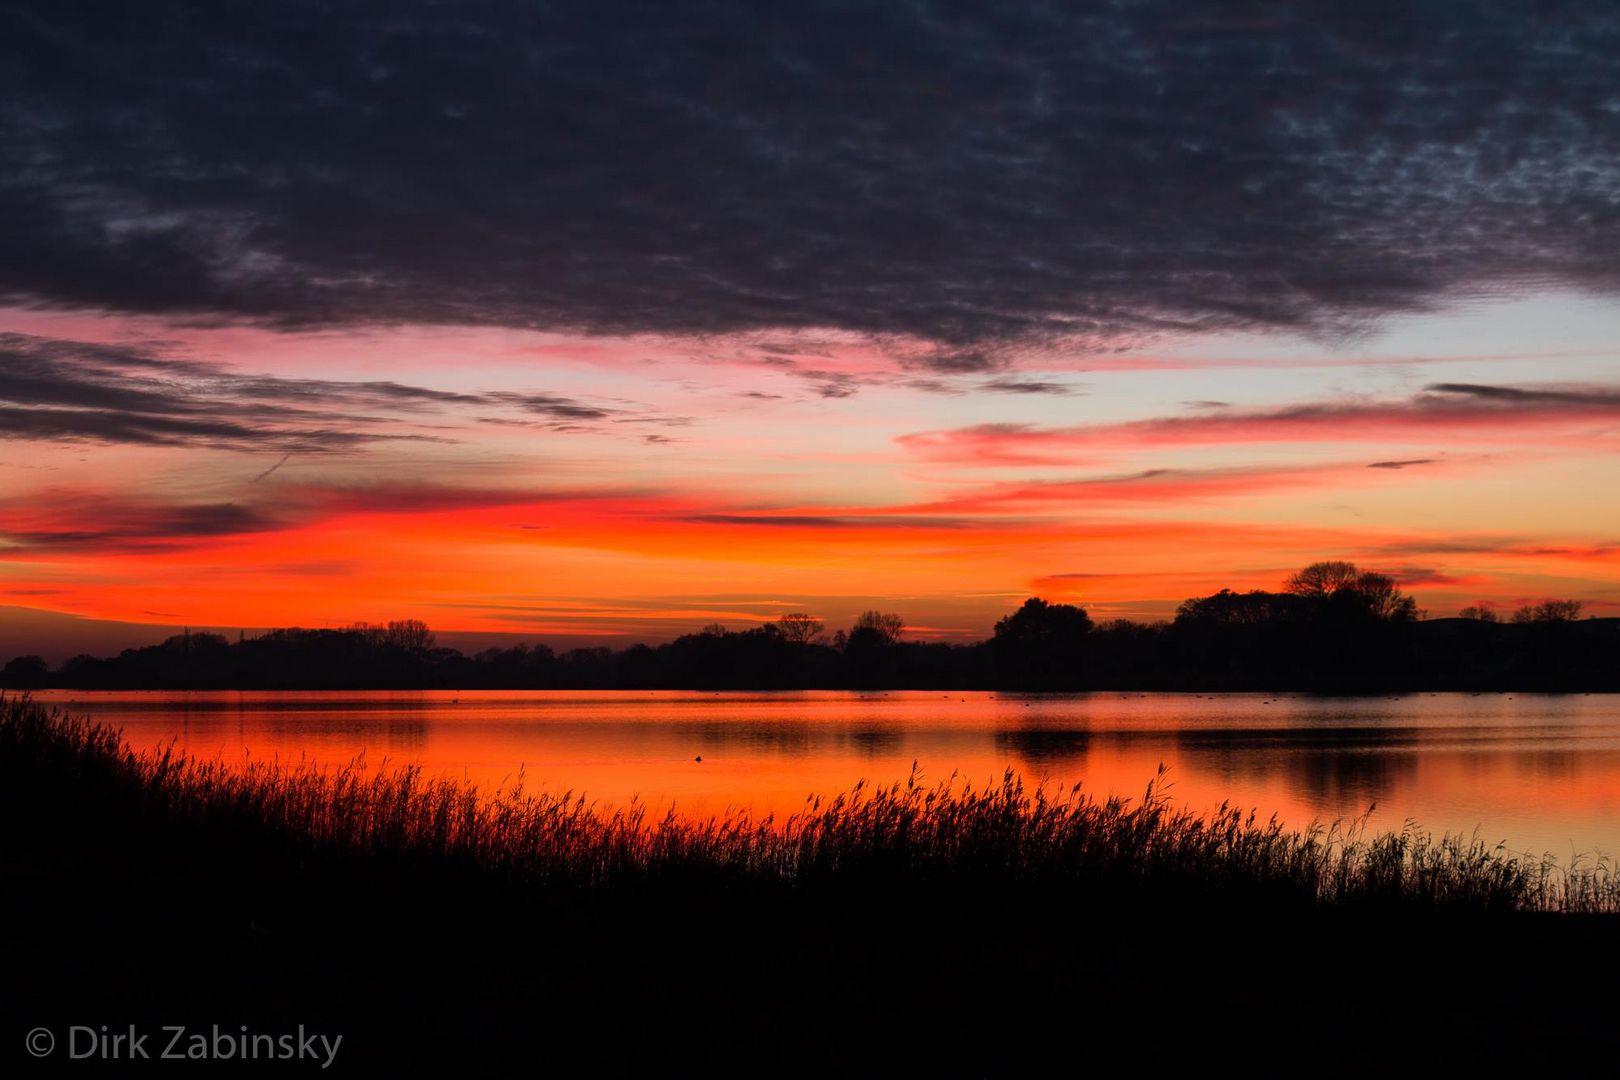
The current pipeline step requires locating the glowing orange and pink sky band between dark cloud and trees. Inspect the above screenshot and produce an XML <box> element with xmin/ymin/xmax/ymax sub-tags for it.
<box><xmin>0</xmin><ymin>295</ymin><xmax>1620</xmax><ymax>654</ymax></box>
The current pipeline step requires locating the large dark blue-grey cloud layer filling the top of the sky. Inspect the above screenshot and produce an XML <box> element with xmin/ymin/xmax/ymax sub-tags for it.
<box><xmin>0</xmin><ymin>0</ymin><xmax>1620</xmax><ymax>346</ymax></box>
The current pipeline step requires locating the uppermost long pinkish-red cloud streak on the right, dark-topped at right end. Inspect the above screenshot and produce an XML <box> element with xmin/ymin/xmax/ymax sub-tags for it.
<box><xmin>897</xmin><ymin>382</ymin><xmax>1620</xmax><ymax>468</ymax></box>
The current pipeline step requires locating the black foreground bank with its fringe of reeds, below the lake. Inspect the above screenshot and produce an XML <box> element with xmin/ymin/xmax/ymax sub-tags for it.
<box><xmin>0</xmin><ymin>699</ymin><xmax>1620</xmax><ymax>1075</ymax></box>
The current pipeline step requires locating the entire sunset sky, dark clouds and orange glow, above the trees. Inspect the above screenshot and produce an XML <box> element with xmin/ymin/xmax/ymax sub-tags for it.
<box><xmin>0</xmin><ymin>0</ymin><xmax>1620</xmax><ymax>654</ymax></box>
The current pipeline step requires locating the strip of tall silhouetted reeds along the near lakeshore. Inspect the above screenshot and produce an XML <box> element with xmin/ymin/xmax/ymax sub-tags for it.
<box><xmin>0</xmin><ymin>698</ymin><xmax>1620</xmax><ymax>913</ymax></box>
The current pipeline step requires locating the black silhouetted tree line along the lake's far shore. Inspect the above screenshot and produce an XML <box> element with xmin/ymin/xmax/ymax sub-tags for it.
<box><xmin>0</xmin><ymin>562</ymin><xmax>1620</xmax><ymax>693</ymax></box>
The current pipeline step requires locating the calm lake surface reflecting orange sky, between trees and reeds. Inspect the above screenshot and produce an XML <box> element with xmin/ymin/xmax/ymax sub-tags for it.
<box><xmin>36</xmin><ymin>690</ymin><xmax>1620</xmax><ymax>861</ymax></box>
